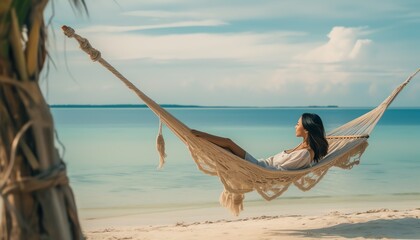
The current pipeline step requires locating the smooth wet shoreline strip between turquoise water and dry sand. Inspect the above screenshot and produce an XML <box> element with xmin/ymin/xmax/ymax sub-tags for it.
<box><xmin>78</xmin><ymin>193</ymin><xmax>420</xmax><ymax>220</ymax></box>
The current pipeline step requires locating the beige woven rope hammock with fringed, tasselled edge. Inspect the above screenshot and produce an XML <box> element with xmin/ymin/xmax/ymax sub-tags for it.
<box><xmin>62</xmin><ymin>26</ymin><xmax>420</xmax><ymax>215</ymax></box>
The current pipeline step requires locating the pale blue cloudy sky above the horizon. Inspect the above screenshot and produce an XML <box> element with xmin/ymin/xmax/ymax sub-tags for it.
<box><xmin>41</xmin><ymin>0</ymin><xmax>420</xmax><ymax>107</ymax></box>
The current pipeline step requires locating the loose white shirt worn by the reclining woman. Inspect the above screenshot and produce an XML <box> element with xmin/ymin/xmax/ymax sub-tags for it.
<box><xmin>263</xmin><ymin>149</ymin><xmax>312</xmax><ymax>170</ymax></box>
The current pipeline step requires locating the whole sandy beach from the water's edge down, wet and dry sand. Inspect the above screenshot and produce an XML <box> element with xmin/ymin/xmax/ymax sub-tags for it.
<box><xmin>83</xmin><ymin>197</ymin><xmax>420</xmax><ymax>240</ymax></box>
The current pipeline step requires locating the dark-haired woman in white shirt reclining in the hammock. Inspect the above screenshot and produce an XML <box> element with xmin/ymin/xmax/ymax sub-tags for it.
<box><xmin>191</xmin><ymin>113</ymin><xmax>328</xmax><ymax>170</ymax></box>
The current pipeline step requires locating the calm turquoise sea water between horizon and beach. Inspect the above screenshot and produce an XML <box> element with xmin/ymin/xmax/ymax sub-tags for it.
<box><xmin>52</xmin><ymin>108</ymin><xmax>420</xmax><ymax>211</ymax></box>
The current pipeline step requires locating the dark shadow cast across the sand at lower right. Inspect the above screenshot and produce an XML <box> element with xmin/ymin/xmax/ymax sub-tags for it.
<box><xmin>272</xmin><ymin>218</ymin><xmax>420</xmax><ymax>239</ymax></box>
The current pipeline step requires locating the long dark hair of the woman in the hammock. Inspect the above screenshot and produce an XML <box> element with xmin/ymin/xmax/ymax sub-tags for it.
<box><xmin>302</xmin><ymin>113</ymin><xmax>328</xmax><ymax>162</ymax></box>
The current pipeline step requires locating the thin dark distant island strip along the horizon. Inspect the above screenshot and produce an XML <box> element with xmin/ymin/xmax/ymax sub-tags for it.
<box><xmin>50</xmin><ymin>104</ymin><xmax>338</xmax><ymax>108</ymax></box>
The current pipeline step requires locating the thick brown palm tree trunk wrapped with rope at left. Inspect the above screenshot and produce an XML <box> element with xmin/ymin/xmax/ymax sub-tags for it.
<box><xmin>0</xmin><ymin>0</ymin><xmax>84</xmax><ymax>240</ymax></box>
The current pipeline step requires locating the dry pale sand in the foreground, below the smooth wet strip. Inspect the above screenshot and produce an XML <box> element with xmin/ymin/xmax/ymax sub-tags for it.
<box><xmin>86</xmin><ymin>208</ymin><xmax>420</xmax><ymax>240</ymax></box>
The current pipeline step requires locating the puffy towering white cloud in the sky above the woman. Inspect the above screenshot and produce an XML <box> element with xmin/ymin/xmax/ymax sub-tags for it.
<box><xmin>202</xmin><ymin>27</ymin><xmax>371</xmax><ymax>97</ymax></box>
